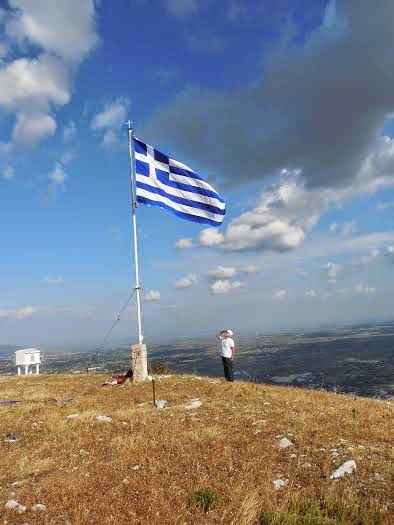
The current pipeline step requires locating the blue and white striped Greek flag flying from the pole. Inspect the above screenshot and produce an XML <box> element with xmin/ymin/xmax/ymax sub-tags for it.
<box><xmin>133</xmin><ymin>137</ymin><xmax>226</xmax><ymax>226</ymax></box>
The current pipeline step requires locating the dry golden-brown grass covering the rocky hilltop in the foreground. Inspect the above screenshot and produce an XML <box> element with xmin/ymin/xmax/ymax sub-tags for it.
<box><xmin>0</xmin><ymin>375</ymin><xmax>392</xmax><ymax>525</ymax></box>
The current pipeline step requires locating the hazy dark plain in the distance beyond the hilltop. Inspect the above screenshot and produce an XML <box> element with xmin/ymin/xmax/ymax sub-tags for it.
<box><xmin>0</xmin><ymin>323</ymin><xmax>394</xmax><ymax>399</ymax></box>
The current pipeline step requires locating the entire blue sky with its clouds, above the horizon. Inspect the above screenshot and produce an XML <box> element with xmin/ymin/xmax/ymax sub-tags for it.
<box><xmin>0</xmin><ymin>0</ymin><xmax>394</xmax><ymax>348</ymax></box>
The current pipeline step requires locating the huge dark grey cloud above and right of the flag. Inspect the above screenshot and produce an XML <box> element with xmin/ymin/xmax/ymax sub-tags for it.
<box><xmin>142</xmin><ymin>0</ymin><xmax>394</xmax><ymax>192</ymax></box>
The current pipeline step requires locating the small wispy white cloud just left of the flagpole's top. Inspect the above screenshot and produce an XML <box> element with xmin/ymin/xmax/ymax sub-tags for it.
<box><xmin>90</xmin><ymin>98</ymin><xmax>129</xmax><ymax>147</ymax></box>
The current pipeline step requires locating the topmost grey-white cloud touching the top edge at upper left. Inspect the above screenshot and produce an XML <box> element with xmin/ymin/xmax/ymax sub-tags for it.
<box><xmin>6</xmin><ymin>0</ymin><xmax>98</xmax><ymax>62</ymax></box>
